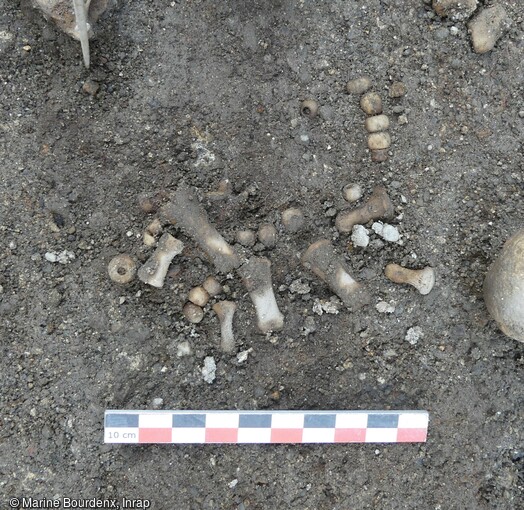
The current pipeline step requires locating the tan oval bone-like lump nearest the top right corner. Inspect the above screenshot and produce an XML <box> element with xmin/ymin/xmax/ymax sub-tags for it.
<box><xmin>468</xmin><ymin>5</ymin><xmax>509</xmax><ymax>53</ymax></box>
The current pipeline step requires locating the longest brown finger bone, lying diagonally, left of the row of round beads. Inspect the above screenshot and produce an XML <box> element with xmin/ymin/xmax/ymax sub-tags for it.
<box><xmin>160</xmin><ymin>186</ymin><xmax>240</xmax><ymax>273</ymax></box>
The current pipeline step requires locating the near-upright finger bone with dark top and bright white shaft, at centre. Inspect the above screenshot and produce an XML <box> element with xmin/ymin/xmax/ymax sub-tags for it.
<box><xmin>238</xmin><ymin>257</ymin><xmax>284</xmax><ymax>333</ymax></box>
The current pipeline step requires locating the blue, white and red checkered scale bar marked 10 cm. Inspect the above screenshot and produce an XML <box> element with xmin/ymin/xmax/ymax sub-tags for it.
<box><xmin>104</xmin><ymin>410</ymin><xmax>429</xmax><ymax>444</ymax></box>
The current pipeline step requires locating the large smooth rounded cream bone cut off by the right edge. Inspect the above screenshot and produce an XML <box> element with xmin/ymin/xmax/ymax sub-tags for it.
<box><xmin>484</xmin><ymin>229</ymin><xmax>524</xmax><ymax>342</ymax></box>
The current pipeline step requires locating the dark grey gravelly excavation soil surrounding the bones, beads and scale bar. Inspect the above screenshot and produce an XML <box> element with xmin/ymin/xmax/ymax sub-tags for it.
<box><xmin>0</xmin><ymin>0</ymin><xmax>524</xmax><ymax>510</ymax></box>
